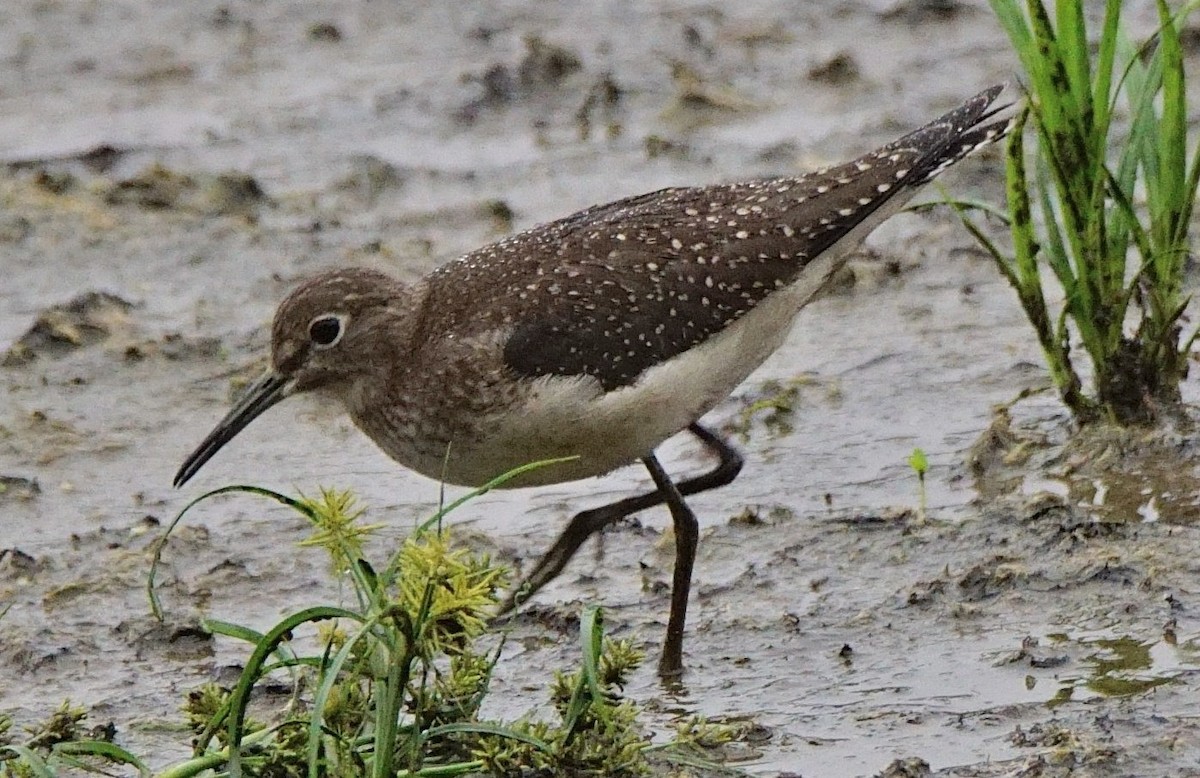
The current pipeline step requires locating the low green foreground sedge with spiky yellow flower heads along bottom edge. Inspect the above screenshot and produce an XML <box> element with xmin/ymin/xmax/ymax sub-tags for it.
<box><xmin>0</xmin><ymin>473</ymin><xmax>744</xmax><ymax>778</ymax></box>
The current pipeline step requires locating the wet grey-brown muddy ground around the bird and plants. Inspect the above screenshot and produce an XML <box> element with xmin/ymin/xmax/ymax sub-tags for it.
<box><xmin>0</xmin><ymin>0</ymin><xmax>1200</xmax><ymax>778</ymax></box>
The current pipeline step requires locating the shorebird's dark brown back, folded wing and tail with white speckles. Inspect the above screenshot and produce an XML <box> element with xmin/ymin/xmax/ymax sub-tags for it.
<box><xmin>431</xmin><ymin>88</ymin><xmax>1007</xmax><ymax>390</ymax></box>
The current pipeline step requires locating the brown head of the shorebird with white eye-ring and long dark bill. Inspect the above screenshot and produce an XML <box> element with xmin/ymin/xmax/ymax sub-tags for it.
<box><xmin>174</xmin><ymin>268</ymin><xmax>406</xmax><ymax>486</ymax></box>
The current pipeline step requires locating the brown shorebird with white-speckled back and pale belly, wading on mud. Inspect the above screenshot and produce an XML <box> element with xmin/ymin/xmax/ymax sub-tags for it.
<box><xmin>175</xmin><ymin>86</ymin><xmax>1008</xmax><ymax>677</ymax></box>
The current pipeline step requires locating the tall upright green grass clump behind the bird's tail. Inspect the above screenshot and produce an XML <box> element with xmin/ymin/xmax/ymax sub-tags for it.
<box><xmin>967</xmin><ymin>0</ymin><xmax>1200</xmax><ymax>424</ymax></box>
